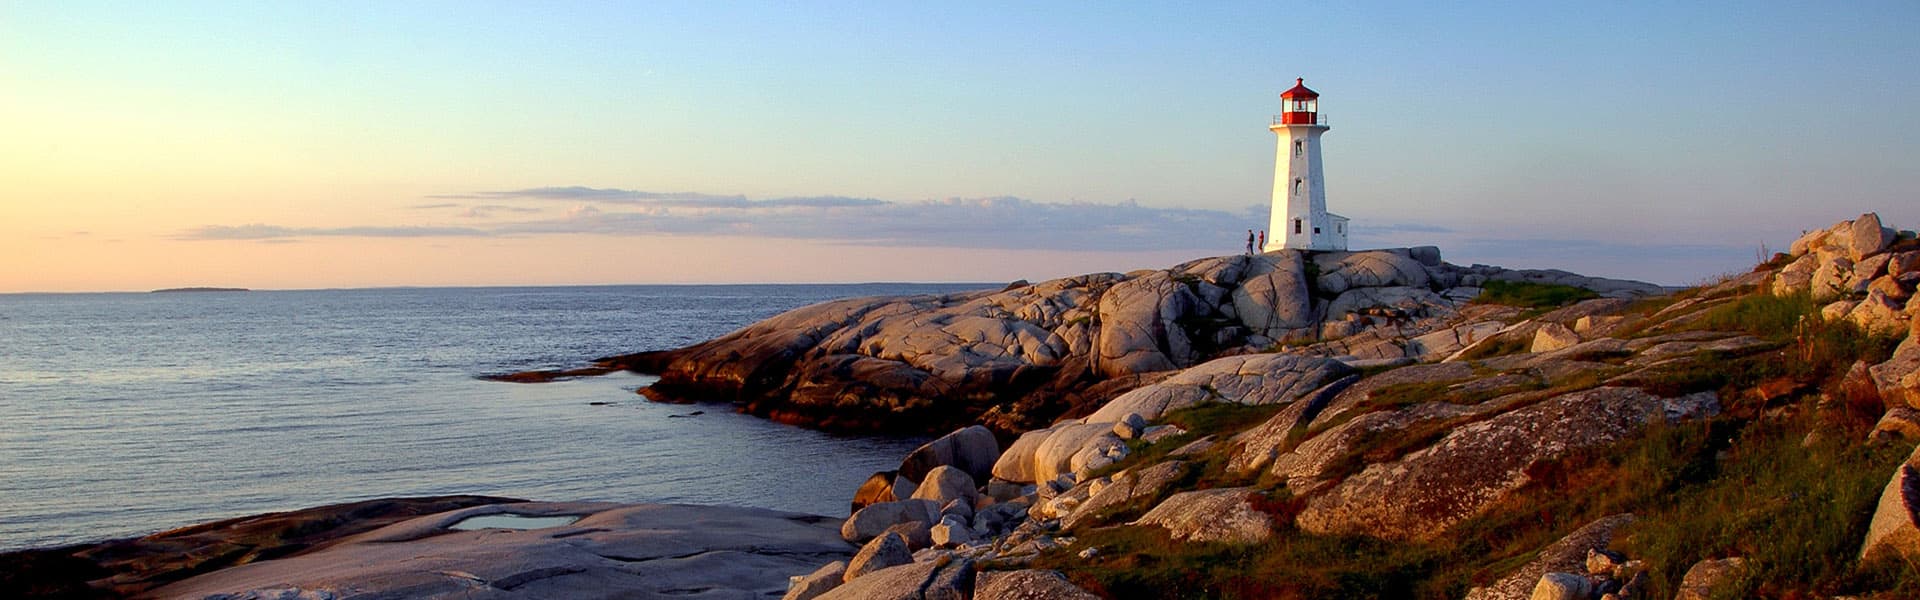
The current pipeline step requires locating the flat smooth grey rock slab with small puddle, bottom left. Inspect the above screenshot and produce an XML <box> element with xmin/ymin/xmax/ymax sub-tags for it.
<box><xmin>150</xmin><ymin>502</ymin><xmax>854</xmax><ymax>598</ymax></box>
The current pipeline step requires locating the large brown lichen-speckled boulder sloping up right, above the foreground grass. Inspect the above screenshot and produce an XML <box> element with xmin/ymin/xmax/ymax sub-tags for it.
<box><xmin>1296</xmin><ymin>387</ymin><xmax>1718</xmax><ymax>540</ymax></box>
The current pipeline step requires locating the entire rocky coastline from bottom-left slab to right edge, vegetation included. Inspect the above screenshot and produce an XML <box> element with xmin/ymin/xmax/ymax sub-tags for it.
<box><xmin>15</xmin><ymin>213</ymin><xmax>1920</xmax><ymax>600</ymax></box>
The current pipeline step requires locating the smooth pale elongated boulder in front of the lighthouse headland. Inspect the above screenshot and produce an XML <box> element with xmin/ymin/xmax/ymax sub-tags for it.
<box><xmin>1087</xmin><ymin>354</ymin><xmax>1354</xmax><ymax>423</ymax></box>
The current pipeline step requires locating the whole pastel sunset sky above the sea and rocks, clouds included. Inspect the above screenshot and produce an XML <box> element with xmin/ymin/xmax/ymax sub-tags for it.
<box><xmin>0</xmin><ymin>0</ymin><xmax>1920</xmax><ymax>292</ymax></box>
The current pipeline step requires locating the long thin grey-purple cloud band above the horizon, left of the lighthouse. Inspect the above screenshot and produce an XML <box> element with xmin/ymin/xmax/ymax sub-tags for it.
<box><xmin>180</xmin><ymin>187</ymin><xmax>1263</xmax><ymax>250</ymax></box>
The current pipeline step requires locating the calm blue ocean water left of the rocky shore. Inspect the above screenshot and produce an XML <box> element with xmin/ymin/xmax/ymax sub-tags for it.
<box><xmin>0</xmin><ymin>285</ymin><xmax>981</xmax><ymax>550</ymax></box>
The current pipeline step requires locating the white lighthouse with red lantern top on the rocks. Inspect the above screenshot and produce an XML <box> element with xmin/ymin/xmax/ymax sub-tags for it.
<box><xmin>1261</xmin><ymin>79</ymin><xmax>1346</xmax><ymax>252</ymax></box>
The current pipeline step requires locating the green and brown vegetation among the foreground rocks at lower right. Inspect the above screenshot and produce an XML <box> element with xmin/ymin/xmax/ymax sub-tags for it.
<box><xmin>1037</xmin><ymin>284</ymin><xmax>1920</xmax><ymax>598</ymax></box>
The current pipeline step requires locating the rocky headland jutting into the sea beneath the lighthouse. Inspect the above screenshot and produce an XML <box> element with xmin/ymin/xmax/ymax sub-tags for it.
<box><xmin>499</xmin><ymin>248</ymin><xmax>1659</xmax><ymax>432</ymax></box>
